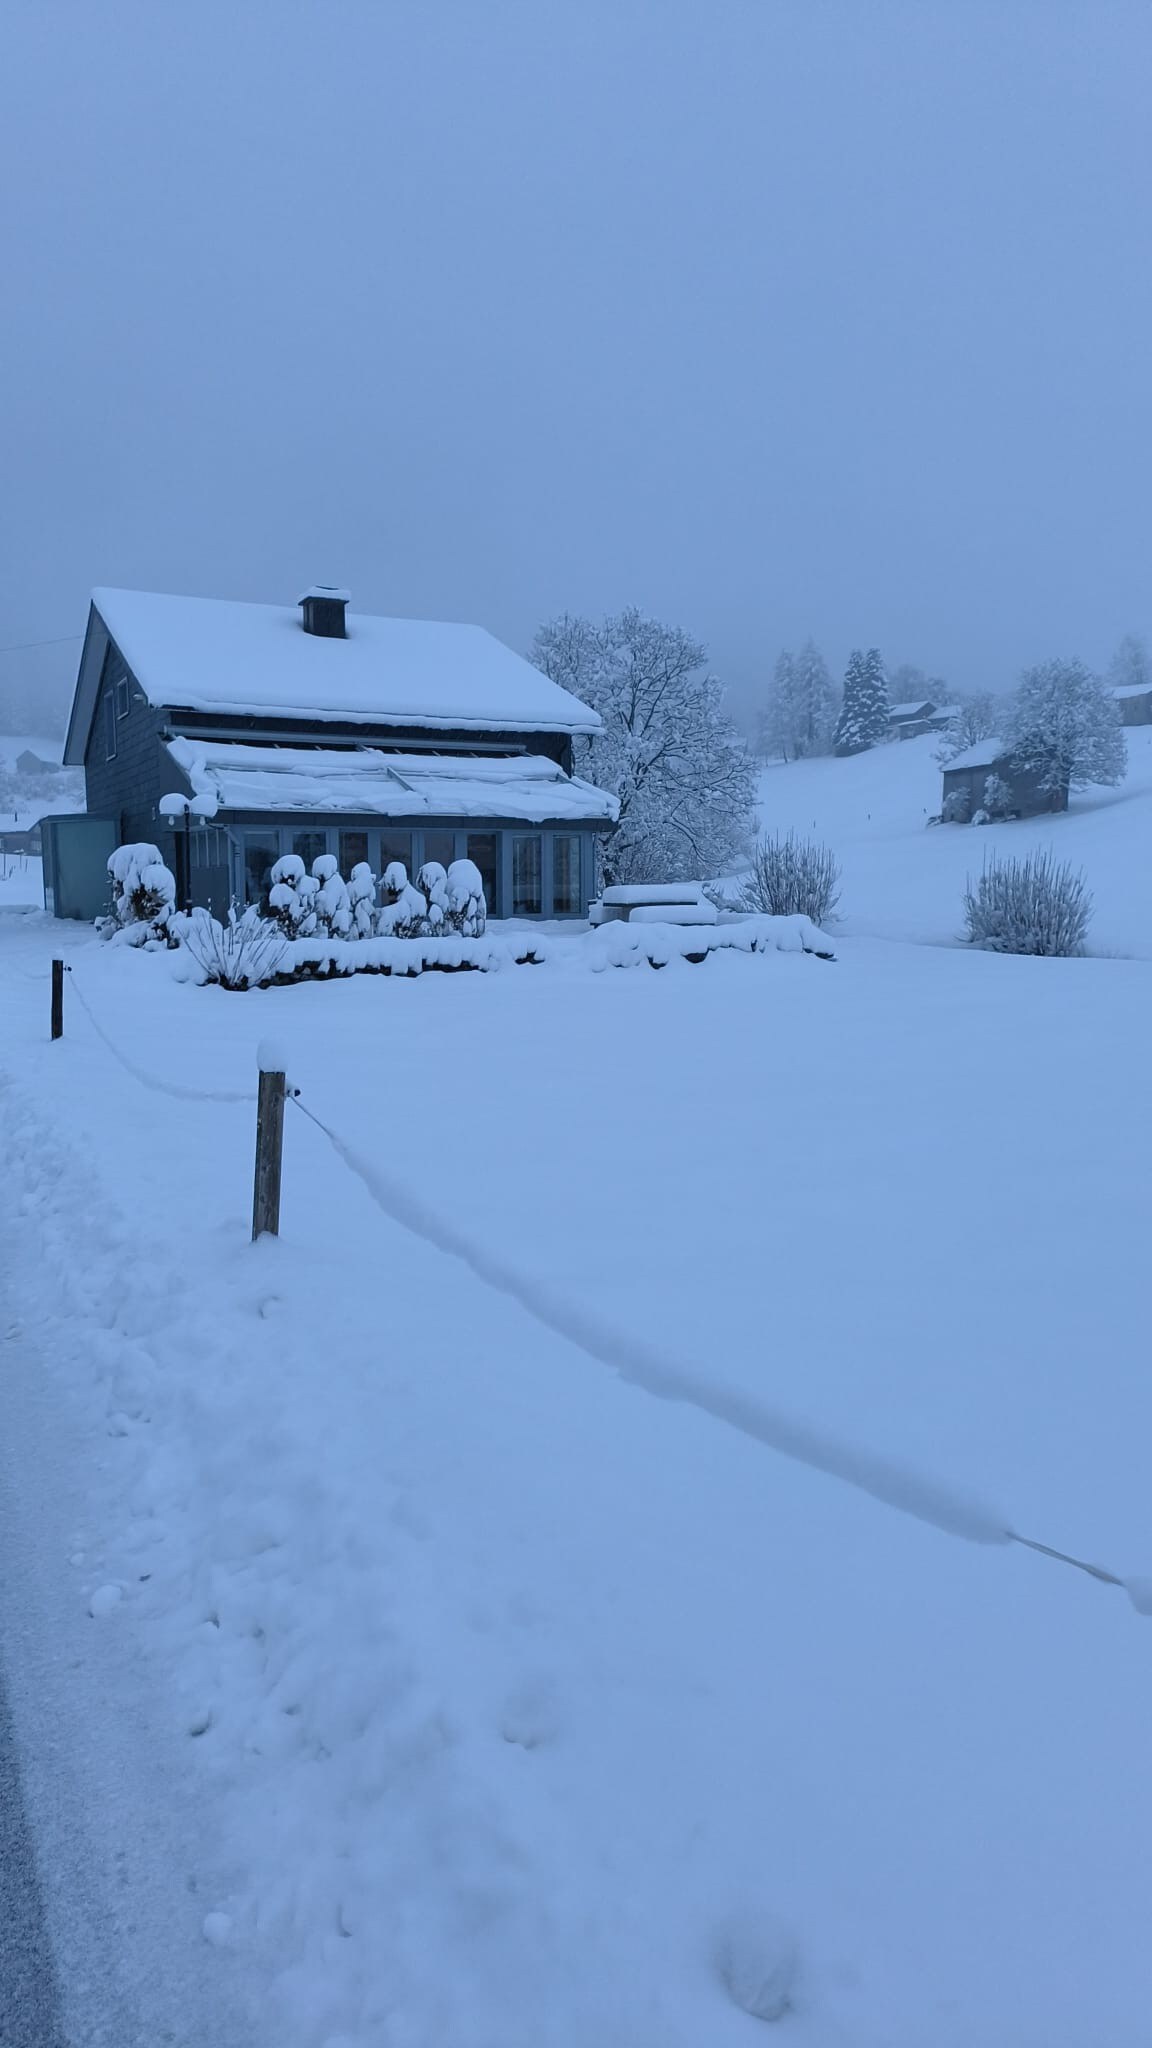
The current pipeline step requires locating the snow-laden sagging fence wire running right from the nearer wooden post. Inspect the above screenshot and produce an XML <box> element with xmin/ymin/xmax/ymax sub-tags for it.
<box><xmin>287</xmin><ymin>1094</ymin><xmax>1152</xmax><ymax>1614</ymax></box>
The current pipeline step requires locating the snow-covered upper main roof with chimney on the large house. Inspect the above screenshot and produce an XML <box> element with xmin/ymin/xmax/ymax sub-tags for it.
<box><xmin>84</xmin><ymin>590</ymin><xmax>601</xmax><ymax>739</ymax></box>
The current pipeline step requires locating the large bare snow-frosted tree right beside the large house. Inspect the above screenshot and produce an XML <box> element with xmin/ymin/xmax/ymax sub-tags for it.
<box><xmin>531</xmin><ymin>608</ymin><xmax>756</xmax><ymax>883</ymax></box>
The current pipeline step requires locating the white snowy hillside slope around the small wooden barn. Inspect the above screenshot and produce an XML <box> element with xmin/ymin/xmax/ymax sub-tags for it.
<box><xmin>760</xmin><ymin>727</ymin><xmax>1152</xmax><ymax>958</ymax></box>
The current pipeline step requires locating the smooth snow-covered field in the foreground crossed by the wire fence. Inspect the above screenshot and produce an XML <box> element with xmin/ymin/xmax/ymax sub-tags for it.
<box><xmin>0</xmin><ymin>909</ymin><xmax>1152</xmax><ymax>2048</ymax></box>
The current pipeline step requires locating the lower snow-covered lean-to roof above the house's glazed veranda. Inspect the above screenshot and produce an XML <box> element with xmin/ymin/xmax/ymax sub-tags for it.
<box><xmin>168</xmin><ymin>739</ymin><xmax>617</xmax><ymax>825</ymax></box>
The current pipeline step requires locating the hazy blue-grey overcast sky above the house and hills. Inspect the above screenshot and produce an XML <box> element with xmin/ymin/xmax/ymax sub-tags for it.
<box><xmin>0</xmin><ymin>0</ymin><xmax>1152</xmax><ymax>733</ymax></box>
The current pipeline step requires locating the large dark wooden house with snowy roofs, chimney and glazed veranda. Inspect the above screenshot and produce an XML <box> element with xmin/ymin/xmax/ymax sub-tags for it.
<box><xmin>64</xmin><ymin>586</ymin><xmax>617</xmax><ymax>918</ymax></box>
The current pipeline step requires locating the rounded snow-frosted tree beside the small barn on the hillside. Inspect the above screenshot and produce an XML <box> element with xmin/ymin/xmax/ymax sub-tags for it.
<box><xmin>1004</xmin><ymin>659</ymin><xmax>1127</xmax><ymax>795</ymax></box>
